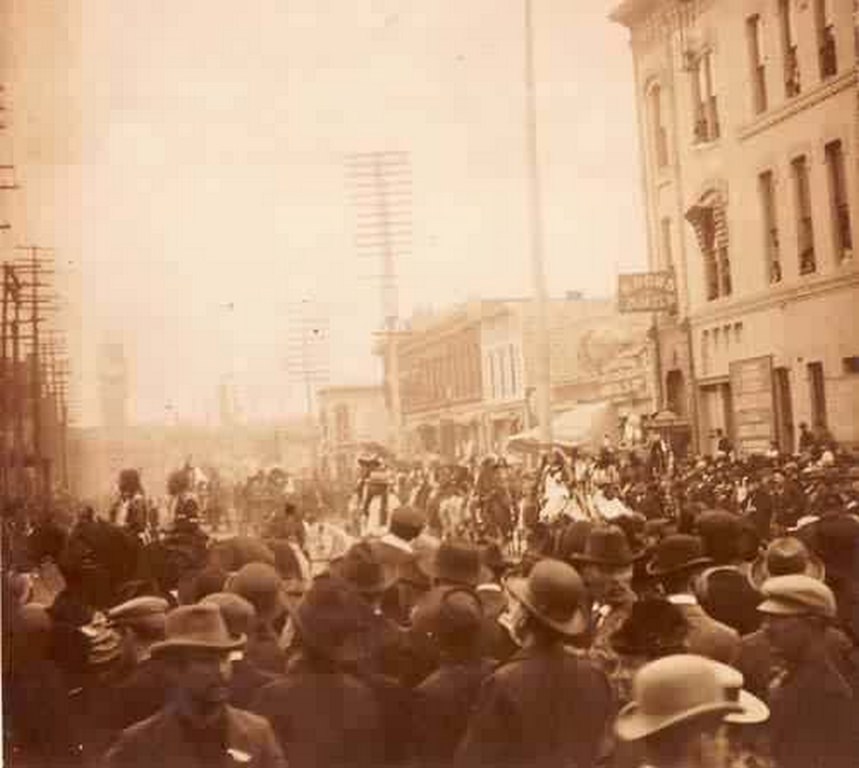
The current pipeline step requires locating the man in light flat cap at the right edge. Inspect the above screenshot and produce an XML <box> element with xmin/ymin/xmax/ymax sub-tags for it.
<box><xmin>758</xmin><ymin>574</ymin><xmax>859</xmax><ymax>768</ymax></box>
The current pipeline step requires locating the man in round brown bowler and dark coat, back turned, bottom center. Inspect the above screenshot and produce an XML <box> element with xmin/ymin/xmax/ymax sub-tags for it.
<box><xmin>455</xmin><ymin>559</ymin><xmax>613</xmax><ymax>768</ymax></box>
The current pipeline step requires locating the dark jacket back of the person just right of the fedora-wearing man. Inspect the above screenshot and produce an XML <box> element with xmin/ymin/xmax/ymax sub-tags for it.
<box><xmin>251</xmin><ymin>662</ymin><xmax>384</xmax><ymax>768</ymax></box>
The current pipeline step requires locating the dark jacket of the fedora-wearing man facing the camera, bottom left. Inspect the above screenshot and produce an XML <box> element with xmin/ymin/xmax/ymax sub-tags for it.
<box><xmin>105</xmin><ymin>705</ymin><xmax>286</xmax><ymax>768</ymax></box>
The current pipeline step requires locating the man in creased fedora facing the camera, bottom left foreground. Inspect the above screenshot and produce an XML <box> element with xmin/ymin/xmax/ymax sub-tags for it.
<box><xmin>105</xmin><ymin>605</ymin><xmax>286</xmax><ymax>768</ymax></box>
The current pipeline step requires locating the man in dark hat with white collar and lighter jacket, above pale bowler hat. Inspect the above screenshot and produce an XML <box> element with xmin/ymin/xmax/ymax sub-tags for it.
<box><xmin>647</xmin><ymin>533</ymin><xmax>740</xmax><ymax>664</ymax></box>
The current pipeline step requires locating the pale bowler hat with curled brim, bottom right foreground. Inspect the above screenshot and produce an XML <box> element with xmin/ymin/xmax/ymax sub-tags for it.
<box><xmin>615</xmin><ymin>654</ymin><xmax>743</xmax><ymax>741</ymax></box>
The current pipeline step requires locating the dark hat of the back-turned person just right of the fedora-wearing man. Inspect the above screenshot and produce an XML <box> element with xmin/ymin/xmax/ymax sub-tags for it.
<box><xmin>290</xmin><ymin>575</ymin><xmax>372</xmax><ymax>663</ymax></box>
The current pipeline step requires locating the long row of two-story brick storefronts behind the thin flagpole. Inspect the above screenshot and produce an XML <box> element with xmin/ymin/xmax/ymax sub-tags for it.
<box><xmin>397</xmin><ymin>294</ymin><xmax>653</xmax><ymax>457</ymax></box>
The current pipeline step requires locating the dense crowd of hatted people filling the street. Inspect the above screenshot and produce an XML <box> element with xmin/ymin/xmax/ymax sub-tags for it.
<box><xmin>3</xmin><ymin>432</ymin><xmax>859</xmax><ymax>768</ymax></box>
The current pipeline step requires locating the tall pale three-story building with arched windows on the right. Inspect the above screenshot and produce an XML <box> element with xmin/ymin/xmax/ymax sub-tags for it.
<box><xmin>612</xmin><ymin>0</ymin><xmax>859</xmax><ymax>451</ymax></box>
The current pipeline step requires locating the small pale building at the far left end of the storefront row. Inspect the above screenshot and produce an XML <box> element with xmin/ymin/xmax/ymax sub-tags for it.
<box><xmin>316</xmin><ymin>386</ymin><xmax>389</xmax><ymax>481</ymax></box>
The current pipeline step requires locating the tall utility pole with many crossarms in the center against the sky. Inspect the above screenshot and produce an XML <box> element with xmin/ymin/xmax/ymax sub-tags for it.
<box><xmin>346</xmin><ymin>151</ymin><xmax>412</xmax><ymax>455</ymax></box>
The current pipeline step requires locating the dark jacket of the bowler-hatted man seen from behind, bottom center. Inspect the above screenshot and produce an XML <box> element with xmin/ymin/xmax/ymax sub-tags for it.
<box><xmin>455</xmin><ymin>647</ymin><xmax>614</xmax><ymax>768</ymax></box>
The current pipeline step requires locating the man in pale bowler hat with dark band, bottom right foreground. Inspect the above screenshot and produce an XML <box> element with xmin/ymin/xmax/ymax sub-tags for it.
<box><xmin>615</xmin><ymin>654</ymin><xmax>766</xmax><ymax>768</ymax></box>
